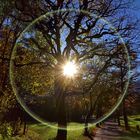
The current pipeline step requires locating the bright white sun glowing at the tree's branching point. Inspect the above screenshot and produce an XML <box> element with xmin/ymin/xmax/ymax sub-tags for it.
<box><xmin>63</xmin><ymin>62</ymin><xmax>77</xmax><ymax>77</ymax></box>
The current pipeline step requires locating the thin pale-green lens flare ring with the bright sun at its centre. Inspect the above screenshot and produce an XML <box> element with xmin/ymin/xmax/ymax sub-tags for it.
<box><xmin>9</xmin><ymin>9</ymin><xmax>131</xmax><ymax>130</ymax></box>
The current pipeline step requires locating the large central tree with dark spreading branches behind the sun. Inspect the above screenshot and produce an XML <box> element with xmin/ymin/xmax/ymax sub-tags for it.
<box><xmin>0</xmin><ymin>0</ymin><xmax>139</xmax><ymax>140</ymax></box>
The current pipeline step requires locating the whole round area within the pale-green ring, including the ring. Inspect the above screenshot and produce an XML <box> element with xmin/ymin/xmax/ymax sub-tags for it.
<box><xmin>10</xmin><ymin>9</ymin><xmax>130</xmax><ymax>130</ymax></box>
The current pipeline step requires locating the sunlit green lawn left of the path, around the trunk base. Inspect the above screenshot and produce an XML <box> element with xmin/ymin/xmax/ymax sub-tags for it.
<box><xmin>9</xmin><ymin>123</ymin><xmax>95</xmax><ymax>140</ymax></box>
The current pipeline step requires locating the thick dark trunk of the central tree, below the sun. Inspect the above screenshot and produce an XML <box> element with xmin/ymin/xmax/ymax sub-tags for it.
<box><xmin>55</xmin><ymin>65</ymin><xmax>67</xmax><ymax>140</ymax></box>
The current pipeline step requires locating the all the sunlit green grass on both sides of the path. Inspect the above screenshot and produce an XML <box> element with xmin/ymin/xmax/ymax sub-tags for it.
<box><xmin>0</xmin><ymin>115</ymin><xmax>140</xmax><ymax>140</ymax></box>
